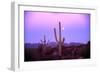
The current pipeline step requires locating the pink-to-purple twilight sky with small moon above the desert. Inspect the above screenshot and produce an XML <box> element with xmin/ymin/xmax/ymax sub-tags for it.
<box><xmin>24</xmin><ymin>11</ymin><xmax>90</xmax><ymax>43</ymax></box>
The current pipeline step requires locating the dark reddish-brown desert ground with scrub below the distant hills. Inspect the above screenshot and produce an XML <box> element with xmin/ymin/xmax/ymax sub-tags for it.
<box><xmin>24</xmin><ymin>42</ymin><xmax>90</xmax><ymax>62</ymax></box>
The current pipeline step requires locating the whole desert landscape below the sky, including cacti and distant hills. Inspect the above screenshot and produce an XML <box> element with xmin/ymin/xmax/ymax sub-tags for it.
<box><xmin>24</xmin><ymin>22</ymin><xmax>90</xmax><ymax>61</ymax></box>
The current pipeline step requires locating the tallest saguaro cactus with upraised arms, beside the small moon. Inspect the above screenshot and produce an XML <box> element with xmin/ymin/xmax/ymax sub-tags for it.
<box><xmin>54</xmin><ymin>22</ymin><xmax>65</xmax><ymax>56</ymax></box>
